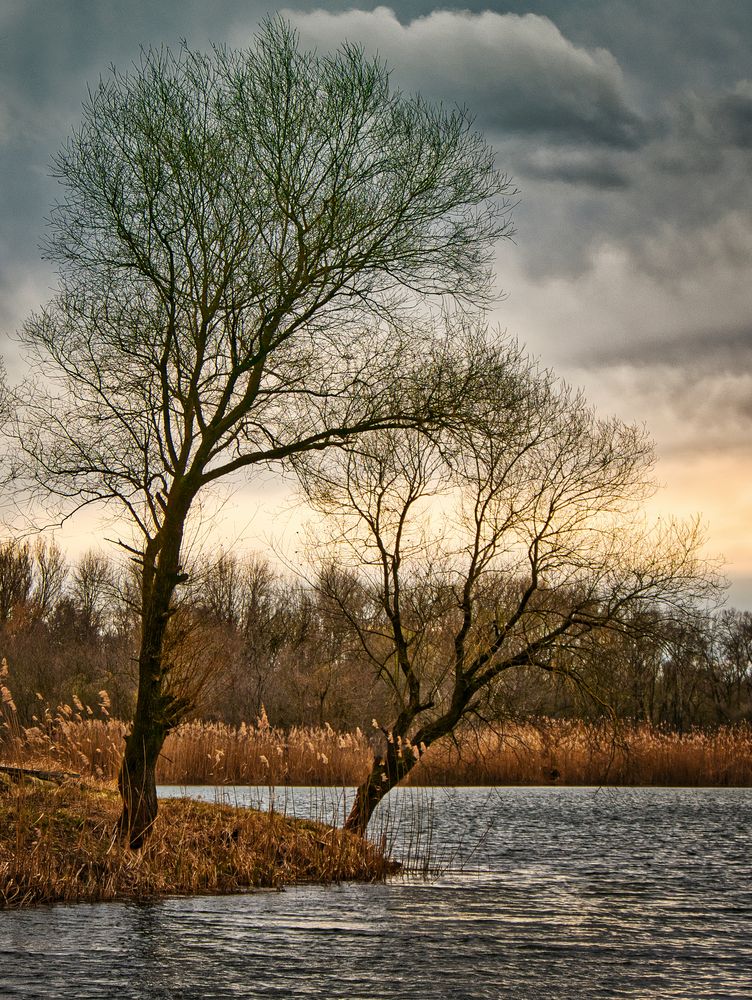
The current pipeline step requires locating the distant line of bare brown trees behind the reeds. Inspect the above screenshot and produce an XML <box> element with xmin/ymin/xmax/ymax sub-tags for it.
<box><xmin>0</xmin><ymin>539</ymin><xmax>752</xmax><ymax>733</ymax></box>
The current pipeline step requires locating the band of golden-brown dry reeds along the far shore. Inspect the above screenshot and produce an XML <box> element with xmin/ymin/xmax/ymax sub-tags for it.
<box><xmin>5</xmin><ymin>706</ymin><xmax>752</xmax><ymax>786</ymax></box>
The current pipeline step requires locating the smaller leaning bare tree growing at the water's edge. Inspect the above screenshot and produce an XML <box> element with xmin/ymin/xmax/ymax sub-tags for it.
<box><xmin>303</xmin><ymin>339</ymin><xmax>716</xmax><ymax>833</ymax></box>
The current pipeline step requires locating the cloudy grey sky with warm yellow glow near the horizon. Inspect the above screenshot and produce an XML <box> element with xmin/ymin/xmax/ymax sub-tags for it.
<box><xmin>0</xmin><ymin>0</ymin><xmax>752</xmax><ymax>608</ymax></box>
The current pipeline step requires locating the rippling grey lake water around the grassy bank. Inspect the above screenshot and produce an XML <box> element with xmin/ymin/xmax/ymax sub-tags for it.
<box><xmin>0</xmin><ymin>787</ymin><xmax>752</xmax><ymax>1000</ymax></box>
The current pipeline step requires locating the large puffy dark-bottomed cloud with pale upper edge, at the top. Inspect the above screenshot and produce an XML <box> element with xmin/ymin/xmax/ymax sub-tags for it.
<box><xmin>283</xmin><ymin>7</ymin><xmax>645</xmax><ymax>149</ymax></box>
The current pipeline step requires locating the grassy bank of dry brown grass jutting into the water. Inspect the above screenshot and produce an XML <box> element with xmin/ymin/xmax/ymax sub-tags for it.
<box><xmin>0</xmin><ymin>774</ymin><xmax>396</xmax><ymax>908</ymax></box>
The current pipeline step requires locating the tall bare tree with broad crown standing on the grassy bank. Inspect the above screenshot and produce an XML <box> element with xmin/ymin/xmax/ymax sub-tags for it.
<box><xmin>19</xmin><ymin>20</ymin><xmax>512</xmax><ymax>846</ymax></box>
